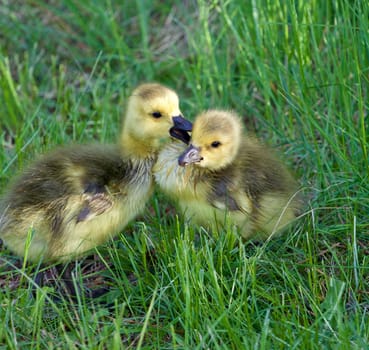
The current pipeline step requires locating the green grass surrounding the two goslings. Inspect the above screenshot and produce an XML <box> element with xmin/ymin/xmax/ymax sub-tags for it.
<box><xmin>0</xmin><ymin>0</ymin><xmax>369</xmax><ymax>349</ymax></box>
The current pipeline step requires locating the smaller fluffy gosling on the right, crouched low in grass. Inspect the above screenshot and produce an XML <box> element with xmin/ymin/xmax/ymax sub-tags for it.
<box><xmin>154</xmin><ymin>110</ymin><xmax>302</xmax><ymax>239</ymax></box>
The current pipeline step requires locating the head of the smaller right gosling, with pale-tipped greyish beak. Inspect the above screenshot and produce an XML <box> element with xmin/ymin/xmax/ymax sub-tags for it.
<box><xmin>178</xmin><ymin>110</ymin><xmax>242</xmax><ymax>170</ymax></box>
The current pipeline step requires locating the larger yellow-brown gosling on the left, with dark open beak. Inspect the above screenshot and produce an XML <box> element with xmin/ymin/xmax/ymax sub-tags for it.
<box><xmin>0</xmin><ymin>83</ymin><xmax>192</xmax><ymax>263</ymax></box>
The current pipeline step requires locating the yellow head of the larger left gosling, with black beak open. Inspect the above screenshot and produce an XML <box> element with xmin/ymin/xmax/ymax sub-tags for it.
<box><xmin>122</xmin><ymin>83</ymin><xmax>192</xmax><ymax>151</ymax></box>
